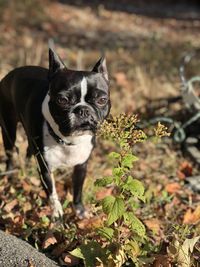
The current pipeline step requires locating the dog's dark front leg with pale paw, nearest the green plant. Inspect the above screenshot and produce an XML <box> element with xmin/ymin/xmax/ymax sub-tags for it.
<box><xmin>72</xmin><ymin>162</ymin><xmax>87</xmax><ymax>218</ymax></box>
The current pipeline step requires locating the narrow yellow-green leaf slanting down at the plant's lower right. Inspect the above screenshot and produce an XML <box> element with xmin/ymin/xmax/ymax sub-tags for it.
<box><xmin>124</xmin><ymin>212</ymin><xmax>146</xmax><ymax>237</ymax></box>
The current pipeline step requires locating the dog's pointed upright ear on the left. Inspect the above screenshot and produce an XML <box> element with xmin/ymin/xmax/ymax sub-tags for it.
<box><xmin>49</xmin><ymin>48</ymin><xmax>66</xmax><ymax>78</ymax></box>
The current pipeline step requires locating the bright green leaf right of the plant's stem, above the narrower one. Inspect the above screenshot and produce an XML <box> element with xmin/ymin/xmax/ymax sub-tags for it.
<box><xmin>123</xmin><ymin>176</ymin><xmax>144</xmax><ymax>201</ymax></box>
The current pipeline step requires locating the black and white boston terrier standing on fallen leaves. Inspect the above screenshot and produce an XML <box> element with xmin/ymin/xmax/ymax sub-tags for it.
<box><xmin>0</xmin><ymin>49</ymin><xmax>111</xmax><ymax>218</ymax></box>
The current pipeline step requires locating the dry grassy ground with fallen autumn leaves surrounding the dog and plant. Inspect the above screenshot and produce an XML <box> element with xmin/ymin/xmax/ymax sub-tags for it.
<box><xmin>0</xmin><ymin>0</ymin><xmax>200</xmax><ymax>266</ymax></box>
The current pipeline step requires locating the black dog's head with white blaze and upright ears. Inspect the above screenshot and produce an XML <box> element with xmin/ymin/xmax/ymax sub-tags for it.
<box><xmin>45</xmin><ymin>49</ymin><xmax>110</xmax><ymax>136</ymax></box>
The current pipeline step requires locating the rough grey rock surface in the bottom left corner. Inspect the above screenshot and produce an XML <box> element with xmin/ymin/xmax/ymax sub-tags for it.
<box><xmin>0</xmin><ymin>231</ymin><xmax>59</xmax><ymax>267</ymax></box>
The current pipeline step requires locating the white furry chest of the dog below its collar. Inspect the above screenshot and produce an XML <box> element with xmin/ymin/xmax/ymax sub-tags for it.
<box><xmin>43</xmin><ymin>123</ymin><xmax>93</xmax><ymax>171</ymax></box>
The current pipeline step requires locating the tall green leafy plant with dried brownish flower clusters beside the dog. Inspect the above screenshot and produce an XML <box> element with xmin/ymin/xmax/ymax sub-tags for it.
<box><xmin>71</xmin><ymin>114</ymin><xmax>166</xmax><ymax>267</ymax></box>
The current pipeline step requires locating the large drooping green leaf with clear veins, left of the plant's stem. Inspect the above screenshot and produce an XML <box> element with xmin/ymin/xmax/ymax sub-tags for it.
<box><xmin>102</xmin><ymin>196</ymin><xmax>125</xmax><ymax>226</ymax></box>
